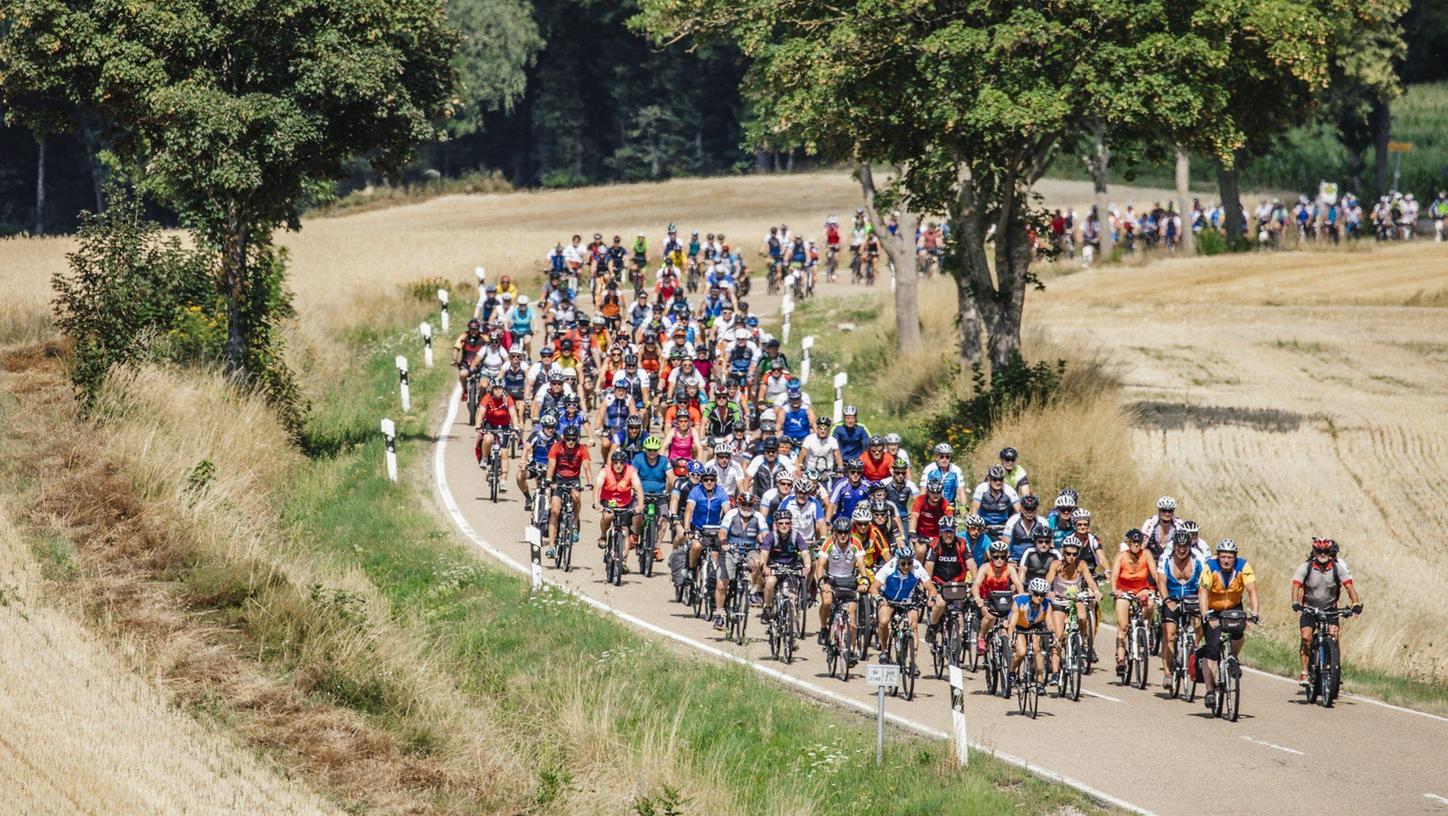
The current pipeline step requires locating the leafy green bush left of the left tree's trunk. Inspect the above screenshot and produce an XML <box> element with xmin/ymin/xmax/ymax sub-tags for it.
<box><xmin>52</xmin><ymin>185</ymin><xmax>217</xmax><ymax>408</ymax></box>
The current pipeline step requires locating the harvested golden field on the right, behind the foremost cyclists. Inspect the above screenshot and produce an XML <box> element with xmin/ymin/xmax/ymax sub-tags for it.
<box><xmin>1022</xmin><ymin>243</ymin><xmax>1448</xmax><ymax>683</ymax></box>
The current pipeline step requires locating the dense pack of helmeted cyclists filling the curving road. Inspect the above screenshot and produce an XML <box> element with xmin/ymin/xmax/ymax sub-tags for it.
<box><xmin>452</xmin><ymin>214</ymin><xmax>1363</xmax><ymax>720</ymax></box>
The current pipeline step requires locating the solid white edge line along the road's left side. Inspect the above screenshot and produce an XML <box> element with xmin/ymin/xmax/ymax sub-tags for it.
<box><xmin>433</xmin><ymin>386</ymin><xmax>1156</xmax><ymax>816</ymax></box>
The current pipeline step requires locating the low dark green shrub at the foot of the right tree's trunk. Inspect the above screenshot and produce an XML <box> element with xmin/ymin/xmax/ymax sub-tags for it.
<box><xmin>912</xmin><ymin>354</ymin><xmax>1066</xmax><ymax>451</ymax></box>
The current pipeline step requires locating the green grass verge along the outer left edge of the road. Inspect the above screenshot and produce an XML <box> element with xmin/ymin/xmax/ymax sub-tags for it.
<box><xmin>279</xmin><ymin>292</ymin><xmax>1117</xmax><ymax>815</ymax></box>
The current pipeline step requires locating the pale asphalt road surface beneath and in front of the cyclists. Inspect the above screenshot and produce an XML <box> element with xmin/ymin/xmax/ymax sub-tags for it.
<box><xmin>434</xmin><ymin>277</ymin><xmax>1448</xmax><ymax>816</ymax></box>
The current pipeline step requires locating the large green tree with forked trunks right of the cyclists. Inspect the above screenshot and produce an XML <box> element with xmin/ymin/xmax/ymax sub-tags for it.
<box><xmin>641</xmin><ymin>0</ymin><xmax>1251</xmax><ymax>367</ymax></box>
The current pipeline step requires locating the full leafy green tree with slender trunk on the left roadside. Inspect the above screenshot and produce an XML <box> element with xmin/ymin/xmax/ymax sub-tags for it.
<box><xmin>0</xmin><ymin>0</ymin><xmax>456</xmax><ymax>389</ymax></box>
